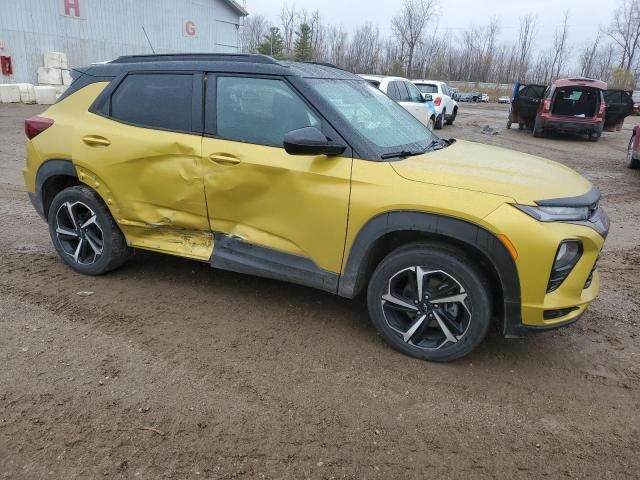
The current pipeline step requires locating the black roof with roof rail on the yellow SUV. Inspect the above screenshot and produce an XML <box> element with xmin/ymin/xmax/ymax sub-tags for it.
<box><xmin>75</xmin><ymin>53</ymin><xmax>362</xmax><ymax>80</ymax></box>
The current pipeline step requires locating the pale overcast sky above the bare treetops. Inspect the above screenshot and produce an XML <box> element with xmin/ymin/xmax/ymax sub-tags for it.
<box><xmin>247</xmin><ymin>0</ymin><xmax>614</xmax><ymax>47</ymax></box>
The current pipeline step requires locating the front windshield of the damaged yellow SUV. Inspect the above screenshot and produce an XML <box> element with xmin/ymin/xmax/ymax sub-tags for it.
<box><xmin>309</xmin><ymin>79</ymin><xmax>438</xmax><ymax>158</ymax></box>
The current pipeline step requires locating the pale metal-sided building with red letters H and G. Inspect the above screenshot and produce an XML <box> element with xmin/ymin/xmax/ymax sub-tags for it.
<box><xmin>0</xmin><ymin>0</ymin><xmax>247</xmax><ymax>83</ymax></box>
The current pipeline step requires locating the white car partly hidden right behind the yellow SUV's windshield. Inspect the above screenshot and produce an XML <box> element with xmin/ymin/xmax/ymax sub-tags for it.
<box><xmin>360</xmin><ymin>75</ymin><xmax>436</xmax><ymax>129</ymax></box>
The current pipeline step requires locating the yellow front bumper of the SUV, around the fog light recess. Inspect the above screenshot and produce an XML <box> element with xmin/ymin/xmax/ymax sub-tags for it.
<box><xmin>485</xmin><ymin>205</ymin><xmax>609</xmax><ymax>337</ymax></box>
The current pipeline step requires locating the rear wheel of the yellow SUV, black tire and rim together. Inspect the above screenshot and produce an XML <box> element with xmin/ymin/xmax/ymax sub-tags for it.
<box><xmin>48</xmin><ymin>186</ymin><xmax>133</xmax><ymax>275</ymax></box>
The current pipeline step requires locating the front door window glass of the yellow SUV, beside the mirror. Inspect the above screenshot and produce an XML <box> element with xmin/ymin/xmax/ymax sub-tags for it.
<box><xmin>214</xmin><ymin>77</ymin><xmax>322</xmax><ymax>147</ymax></box>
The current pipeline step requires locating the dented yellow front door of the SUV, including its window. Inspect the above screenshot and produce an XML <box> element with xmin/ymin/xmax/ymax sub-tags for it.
<box><xmin>202</xmin><ymin>75</ymin><xmax>352</xmax><ymax>290</ymax></box>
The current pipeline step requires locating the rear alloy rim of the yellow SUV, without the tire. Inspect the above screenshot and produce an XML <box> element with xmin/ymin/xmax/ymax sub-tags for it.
<box><xmin>55</xmin><ymin>202</ymin><xmax>104</xmax><ymax>265</ymax></box>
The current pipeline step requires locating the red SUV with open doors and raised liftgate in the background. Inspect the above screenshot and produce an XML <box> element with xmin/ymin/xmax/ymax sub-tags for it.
<box><xmin>507</xmin><ymin>78</ymin><xmax>633</xmax><ymax>141</ymax></box>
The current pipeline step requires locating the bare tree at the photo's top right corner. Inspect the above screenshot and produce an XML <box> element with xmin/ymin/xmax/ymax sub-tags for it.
<box><xmin>604</xmin><ymin>0</ymin><xmax>640</xmax><ymax>70</ymax></box>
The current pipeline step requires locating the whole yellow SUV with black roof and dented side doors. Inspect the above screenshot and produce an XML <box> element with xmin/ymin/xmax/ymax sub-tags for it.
<box><xmin>24</xmin><ymin>54</ymin><xmax>609</xmax><ymax>361</ymax></box>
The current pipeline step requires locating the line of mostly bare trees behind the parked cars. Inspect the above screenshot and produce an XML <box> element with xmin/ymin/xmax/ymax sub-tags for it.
<box><xmin>241</xmin><ymin>0</ymin><xmax>640</xmax><ymax>88</ymax></box>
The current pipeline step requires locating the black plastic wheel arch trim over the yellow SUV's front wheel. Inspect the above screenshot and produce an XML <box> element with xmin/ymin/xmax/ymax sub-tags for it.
<box><xmin>338</xmin><ymin>211</ymin><xmax>521</xmax><ymax>334</ymax></box>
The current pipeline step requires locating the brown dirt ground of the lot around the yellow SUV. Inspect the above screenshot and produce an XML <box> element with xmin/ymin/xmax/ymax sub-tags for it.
<box><xmin>0</xmin><ymin>104</ymin><xmax>640</xmax><ymax>480</ymax></box>
